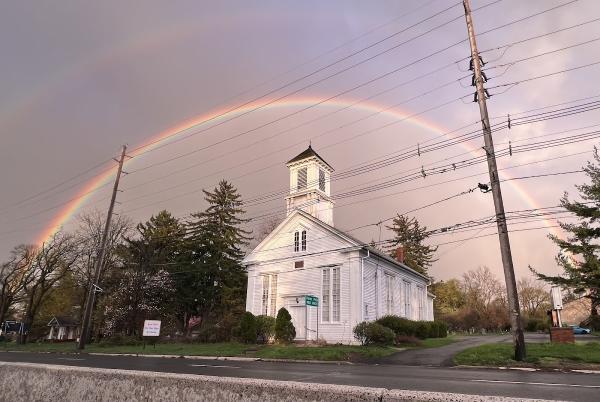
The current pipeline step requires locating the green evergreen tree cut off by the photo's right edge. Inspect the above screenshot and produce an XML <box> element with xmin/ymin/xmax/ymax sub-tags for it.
<box><xmin>530</xmin><ymin>147</ymin><xmax>600</xmax><ymax>316</ymax></box>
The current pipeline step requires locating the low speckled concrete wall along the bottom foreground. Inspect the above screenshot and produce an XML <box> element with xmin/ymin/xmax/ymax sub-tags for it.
<box><xmin>0</xmin><ymin>362</ymin><xmax>548</xmax><ymax>402</ymax></box>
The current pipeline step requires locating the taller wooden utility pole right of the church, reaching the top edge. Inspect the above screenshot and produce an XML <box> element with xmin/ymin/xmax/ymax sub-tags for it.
<box><xmin>463</xmin><ymin>0</ymin><xmax>526</xmax><ymax>361</ymax></box>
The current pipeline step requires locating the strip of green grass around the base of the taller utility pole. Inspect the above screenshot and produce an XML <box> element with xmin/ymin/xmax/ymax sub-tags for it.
<box><xmin>454</xmin><ymin>342</ymin><xmax>600</xmax><ymax>367</ymax></box>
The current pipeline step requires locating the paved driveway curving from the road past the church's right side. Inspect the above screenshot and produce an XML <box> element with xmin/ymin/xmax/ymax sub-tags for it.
<box><xmin>377</xmin><ymin>335</ymin><xmax>512</xmax><ymax>367</ymax></box>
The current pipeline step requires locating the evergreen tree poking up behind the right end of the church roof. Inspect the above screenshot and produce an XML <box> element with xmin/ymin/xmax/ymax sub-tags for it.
<box><xmin>387</xmin><ymin>215</ymin><xmax>437</xmax><ymax>275</ymax></box>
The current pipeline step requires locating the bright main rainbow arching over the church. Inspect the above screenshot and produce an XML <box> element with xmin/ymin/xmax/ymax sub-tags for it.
<box><xmin>36</xmin><ymin>97</ymin><xmax>558</xmax><ymax>244</ymax></box>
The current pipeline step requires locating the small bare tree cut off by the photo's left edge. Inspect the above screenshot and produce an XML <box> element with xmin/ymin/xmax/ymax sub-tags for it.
<box><xmin>0</xmin><ymin>245</ymin><xmax>35</xmax><ymax>323</ymax></box>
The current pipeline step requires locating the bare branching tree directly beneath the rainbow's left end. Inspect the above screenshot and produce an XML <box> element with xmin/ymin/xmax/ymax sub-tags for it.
<box><xmin>19</xmin><ymin>232</ymin><xmax>78</xmax><ymax>343</ymax></box>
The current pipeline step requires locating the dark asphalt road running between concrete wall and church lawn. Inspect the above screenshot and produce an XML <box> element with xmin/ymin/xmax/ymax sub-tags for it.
<box><xmin>0</xmin><ymin>352</ymin><xmax>600</xmax><ymax>402</ymax></box>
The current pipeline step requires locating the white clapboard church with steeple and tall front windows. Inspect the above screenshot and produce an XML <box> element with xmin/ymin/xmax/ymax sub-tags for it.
<box><xmin>243</xmin><ymin>146</ymin><xmax>433</xmax><ymax>344</ymax></box>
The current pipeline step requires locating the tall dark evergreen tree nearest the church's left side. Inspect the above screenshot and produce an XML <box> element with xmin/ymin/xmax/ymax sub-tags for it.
<box><xmin>178</xmin><ymin>180</ymin><xmax>250</xmax><ymax>330</ymax></box>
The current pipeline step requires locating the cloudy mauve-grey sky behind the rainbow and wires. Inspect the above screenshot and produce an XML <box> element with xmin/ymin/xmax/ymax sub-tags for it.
<box><xmin>0</xmin><ymin>0</ymin><xmax>600</xmax><ymax>279</ymax></box>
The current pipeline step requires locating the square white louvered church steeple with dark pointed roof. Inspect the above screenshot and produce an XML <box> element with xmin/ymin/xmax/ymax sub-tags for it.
<box><xmin>285</xmin><ymin>145</ymin><xmax>334</xmax><ymax>226</ymax></box>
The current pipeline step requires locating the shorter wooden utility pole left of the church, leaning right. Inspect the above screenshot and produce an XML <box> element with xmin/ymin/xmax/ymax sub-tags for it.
<box><xmin>77</xmin><ymin>145</ymin><xmax>127</xmax><ymax>350</ymax></box>
